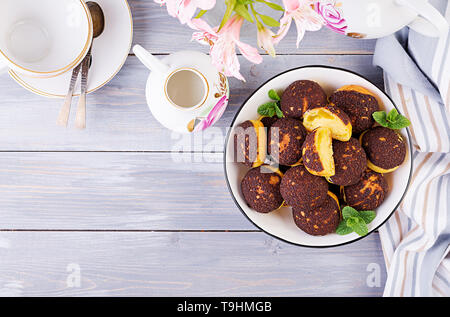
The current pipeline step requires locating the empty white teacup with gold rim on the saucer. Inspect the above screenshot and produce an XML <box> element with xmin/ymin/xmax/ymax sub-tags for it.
<box><xmin>0</xmin><ymin>0</ymin><xmax>93</xmax><ymax>77</ymax></box>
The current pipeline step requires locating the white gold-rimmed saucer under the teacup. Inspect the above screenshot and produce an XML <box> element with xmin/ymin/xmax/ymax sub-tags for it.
<box><xmin>9</xmin><ymin>0</ymin><xmax>133</xmax><ymax>98</ymax></box>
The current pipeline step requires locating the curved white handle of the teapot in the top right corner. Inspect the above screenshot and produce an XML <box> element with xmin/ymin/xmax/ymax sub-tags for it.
<box><xmin>396</xmin><ymin>0</ymin><xmax>449</xmax><ymax>37</ymax></box>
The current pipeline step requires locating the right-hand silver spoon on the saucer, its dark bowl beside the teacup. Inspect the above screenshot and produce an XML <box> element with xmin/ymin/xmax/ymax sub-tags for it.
<box><xmin>75</xmin><ymin>1</ymin><xmax>105</xmax><ymax>129</ymax></box>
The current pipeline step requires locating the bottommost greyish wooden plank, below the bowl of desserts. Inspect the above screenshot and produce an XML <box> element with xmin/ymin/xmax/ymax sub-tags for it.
<box><xmin>0</xmin><ymin>232</ymin><xmax>386</xmax><ymax>297</ymax></box>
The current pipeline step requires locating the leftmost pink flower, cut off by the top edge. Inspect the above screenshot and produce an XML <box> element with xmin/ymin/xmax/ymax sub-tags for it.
<box><xmin>154</xmin><ymin>0</ymin><xmax>216</xmax><ymax>24</ymax></box>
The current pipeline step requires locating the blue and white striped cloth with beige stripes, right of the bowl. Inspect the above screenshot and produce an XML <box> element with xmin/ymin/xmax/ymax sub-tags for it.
<box><xmin>374</xmin><ymin>0</ymin><xmax>450</xmax><ymax>296</ymax></box>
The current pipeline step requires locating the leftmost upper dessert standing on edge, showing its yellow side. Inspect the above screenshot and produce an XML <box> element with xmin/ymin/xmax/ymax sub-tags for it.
<box><xmin>234</xmin><ymin>120</ymin><xmax>267</xmax><ymax>167</ymax></box>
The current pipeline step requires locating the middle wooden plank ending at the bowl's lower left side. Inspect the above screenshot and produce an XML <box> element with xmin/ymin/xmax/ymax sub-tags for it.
<box><xmin>0</xmin><ymin>152</ymin><xmax>250</xmax><ymax>230</ymax></box>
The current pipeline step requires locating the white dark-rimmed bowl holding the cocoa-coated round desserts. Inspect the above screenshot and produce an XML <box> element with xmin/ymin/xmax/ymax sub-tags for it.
<box><xmin>224</xmin><ymin>66</ymin><xmax>413</xmax><ymax>247</ymax></box>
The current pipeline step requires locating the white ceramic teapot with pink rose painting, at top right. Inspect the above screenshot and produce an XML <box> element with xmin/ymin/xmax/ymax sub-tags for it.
<box><xmin>314</xmin><ymin>0</ymin><xmax>448</xmax><ymax>39</ymax></box>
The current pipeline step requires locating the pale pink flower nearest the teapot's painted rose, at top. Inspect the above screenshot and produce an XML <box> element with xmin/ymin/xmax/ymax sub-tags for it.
<box><xmin>274</xmin><ymin>0</ymin><xmax>325</xmax><ymax>47</ymax></box>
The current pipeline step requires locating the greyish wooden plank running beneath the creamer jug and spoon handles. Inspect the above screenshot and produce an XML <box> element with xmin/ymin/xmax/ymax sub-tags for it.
<box><xmin>0</xmin><ymin>55</ymin><xmax>383</xmax><ymax>151</ymax></box>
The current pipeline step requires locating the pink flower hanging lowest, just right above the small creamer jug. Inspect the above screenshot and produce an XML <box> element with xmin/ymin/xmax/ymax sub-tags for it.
<box><xmin>191</xmin><ymin>15</ymin><xmax>262</xmax><ymax>81</ymax></box>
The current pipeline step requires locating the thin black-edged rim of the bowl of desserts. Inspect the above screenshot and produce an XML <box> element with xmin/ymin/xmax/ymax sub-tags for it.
<box><xmin>223</xmin><ymin>64</ymin><xmax>414</xmax><ymax>249</ymax></box>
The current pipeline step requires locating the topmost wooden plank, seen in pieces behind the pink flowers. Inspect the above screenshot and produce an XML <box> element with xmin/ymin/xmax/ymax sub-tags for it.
<box><xmin>129</xmin><ymin>0</ymin><xmax>375</xmax><ymax>54</ymax></box>
